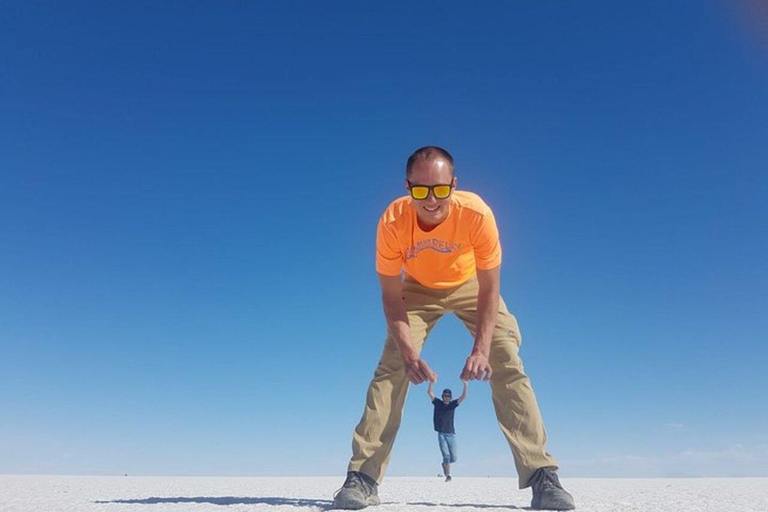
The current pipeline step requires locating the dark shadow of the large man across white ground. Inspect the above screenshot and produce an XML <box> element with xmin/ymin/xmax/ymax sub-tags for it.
<box><xmin>94</xmin><ymin>496</ymin><xmax>532</xmax><ymax>510</ymax></box>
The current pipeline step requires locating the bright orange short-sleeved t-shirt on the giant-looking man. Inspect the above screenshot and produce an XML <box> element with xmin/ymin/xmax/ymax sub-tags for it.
<box><xmin>376</xmin><ymin>190</ymin><xmax>501</xmax><ymax>288</ymax></box>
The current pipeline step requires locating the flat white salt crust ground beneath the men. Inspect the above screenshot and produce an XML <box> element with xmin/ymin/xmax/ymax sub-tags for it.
<box><xmin>0</xmin><ymin>475</ymin><xmax>768</xmax><ymax>512</ymax></box>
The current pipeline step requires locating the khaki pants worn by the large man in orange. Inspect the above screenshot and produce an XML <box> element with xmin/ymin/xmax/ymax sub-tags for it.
<box><xmin>348</xmin><ymin>277</ymin><xmax>557</xmax><ymax>489</ymax></box>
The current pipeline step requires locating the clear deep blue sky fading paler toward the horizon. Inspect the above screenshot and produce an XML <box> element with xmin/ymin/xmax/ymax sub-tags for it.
<box><xmin>0</xmin><ymin>0</ymin><xmax>768</xmax><ymax>476</ymax></box>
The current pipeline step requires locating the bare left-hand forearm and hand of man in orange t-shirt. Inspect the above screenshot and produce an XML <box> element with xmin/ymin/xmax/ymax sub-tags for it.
<box><xmin>379</xmin><ymin>274</ymin><xmax>437</xmax><ymax>384</ymax></box>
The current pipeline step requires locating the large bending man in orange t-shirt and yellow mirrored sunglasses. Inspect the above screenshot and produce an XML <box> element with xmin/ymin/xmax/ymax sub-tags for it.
<box><xmin>334</xmin><ymin>146</ymin><xmax>574</xmax><ymax>510</ymax></box>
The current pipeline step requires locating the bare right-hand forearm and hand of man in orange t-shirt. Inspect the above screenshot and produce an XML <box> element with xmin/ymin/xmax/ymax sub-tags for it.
<box><xmin>461</xmin><ymin>265</ymin><xmax>501</xmax><ymax>380</ymax></box>
